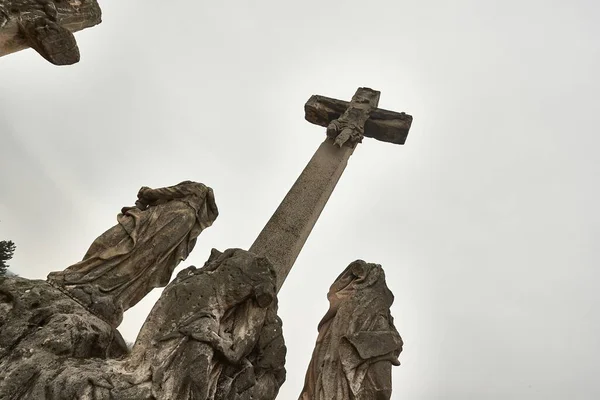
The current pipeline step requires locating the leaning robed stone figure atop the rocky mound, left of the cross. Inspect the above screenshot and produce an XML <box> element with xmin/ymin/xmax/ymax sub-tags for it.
<box><xmin>48</xmin><ymin>181</ymin><xmax>218</xmax><ymax>326</ymax></box>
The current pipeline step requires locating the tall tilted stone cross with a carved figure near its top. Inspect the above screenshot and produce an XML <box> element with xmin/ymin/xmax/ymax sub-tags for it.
<box><xmin>250</xmin><ymin>88</ymin><xmax>412</xmax><ymax>291</ymax></box>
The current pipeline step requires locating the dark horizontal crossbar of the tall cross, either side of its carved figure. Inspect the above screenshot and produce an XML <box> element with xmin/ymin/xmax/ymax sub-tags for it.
<box><xmin>304</xmin><ymin>95</ymin><xmax>412</xmax><ymax>144</ymax></box>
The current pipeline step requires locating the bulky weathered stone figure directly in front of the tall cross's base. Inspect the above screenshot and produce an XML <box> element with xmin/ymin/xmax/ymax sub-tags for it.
<box><xmin>127</xmin><ymin>249</ymin><xmax>285</xmax><ymax>400</ymax></box>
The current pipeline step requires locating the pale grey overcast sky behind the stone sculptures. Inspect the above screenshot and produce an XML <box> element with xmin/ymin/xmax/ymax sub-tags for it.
<box><xmin>0</xmin><ymin>0</ymin><xmax>600</xmax><ymax>400</ymax></box>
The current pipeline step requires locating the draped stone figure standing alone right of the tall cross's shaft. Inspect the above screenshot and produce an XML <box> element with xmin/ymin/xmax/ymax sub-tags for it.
<box><xmin>300</xmin><ymin>260</ymin><xmax>402</xmax><ymax>400</ymax></box>
